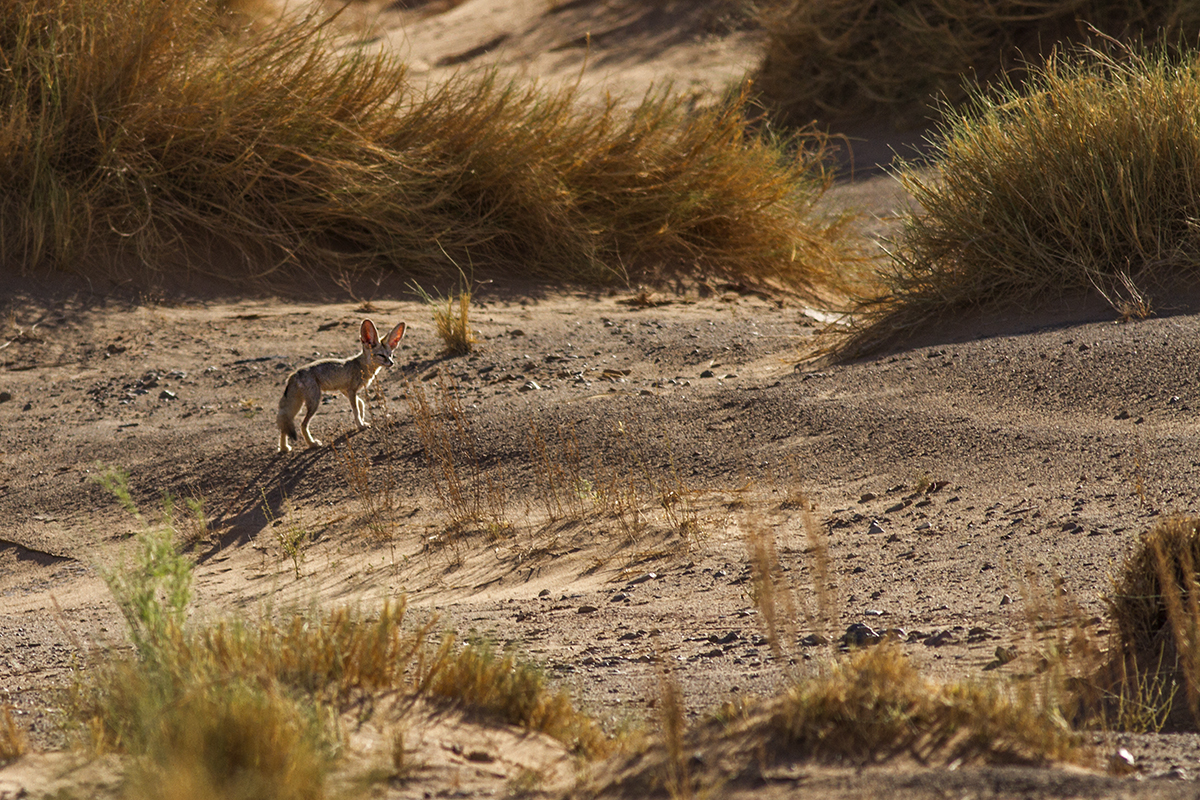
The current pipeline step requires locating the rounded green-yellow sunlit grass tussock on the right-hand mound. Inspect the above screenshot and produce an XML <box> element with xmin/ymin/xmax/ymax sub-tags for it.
<box><xmin>856</xmin><ymin>43</ymin><xmax>1200</xmax><ymax>347</ymax></box>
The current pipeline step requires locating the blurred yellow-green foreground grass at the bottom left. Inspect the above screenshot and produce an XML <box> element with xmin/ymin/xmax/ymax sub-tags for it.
<box><xmin>82</xmin><ymin>470</ymin><xmax>608</xmax><ymax>798</ymax></box>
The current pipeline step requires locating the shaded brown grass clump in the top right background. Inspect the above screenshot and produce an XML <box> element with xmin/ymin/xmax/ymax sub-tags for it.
<box><xmin>755</xmin><ymin>0</ymin><xmax>1200</xmax><ymax>127</ymax></box>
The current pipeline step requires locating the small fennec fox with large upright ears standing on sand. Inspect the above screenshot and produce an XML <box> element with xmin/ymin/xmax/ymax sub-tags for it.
<box><xmin>276</xmin><ymin>319</ymin><xmax>404</xmax><ymax>453</ymax></box>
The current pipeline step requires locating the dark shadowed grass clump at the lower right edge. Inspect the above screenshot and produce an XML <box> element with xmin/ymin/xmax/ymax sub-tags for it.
<box><xmin>1099</xmin><ymin>518</ymin><xmax>1200</xmax><ymax>730</ymax></box>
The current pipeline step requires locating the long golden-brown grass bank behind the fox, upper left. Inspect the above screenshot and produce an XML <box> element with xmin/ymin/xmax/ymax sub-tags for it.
<box><xmin>0</xmin><ymin>0</ymin><xmax>842</xmax><ymax>296</ymax></box>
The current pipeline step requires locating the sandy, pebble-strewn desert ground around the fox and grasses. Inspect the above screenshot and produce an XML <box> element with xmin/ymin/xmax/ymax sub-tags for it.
<box><xmin>0</xmin><ymin>0</ymin><xmax>1200</xmax><ymax>798</ymax></box>
